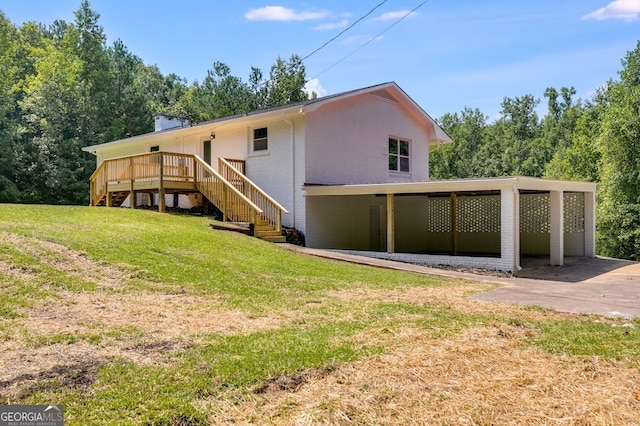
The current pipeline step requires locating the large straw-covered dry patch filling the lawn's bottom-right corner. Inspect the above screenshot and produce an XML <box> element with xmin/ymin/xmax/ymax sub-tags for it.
<box><xmin>224</xmin><ymin>325</ymin><xmax>640</xmax><ymax>425</ymax></box>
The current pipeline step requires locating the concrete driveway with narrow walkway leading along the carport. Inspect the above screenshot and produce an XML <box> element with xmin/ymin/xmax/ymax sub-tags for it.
<box><xmin>282</xmin><ymin>244</ymin><xmax>640</xmax><ymax>318</ymax></box>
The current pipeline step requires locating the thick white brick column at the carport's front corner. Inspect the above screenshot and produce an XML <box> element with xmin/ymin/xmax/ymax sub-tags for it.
<box><xmin>500</xmin><ymin>187</ymin><xmax>520</xmax><ymax>274</ymax></box>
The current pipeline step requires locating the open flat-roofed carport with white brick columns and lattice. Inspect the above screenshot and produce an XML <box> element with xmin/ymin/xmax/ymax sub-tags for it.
<box><xmin>304</xmin><ymin>177</ymin><xmax>596</xmax><ymax>273</ymax></box>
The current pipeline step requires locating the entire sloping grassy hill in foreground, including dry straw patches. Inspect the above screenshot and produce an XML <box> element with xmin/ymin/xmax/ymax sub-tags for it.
<box><xmin>0</xmin><ymin>205</ymin><xmax>640</xmax><ymax>425</ymax></box>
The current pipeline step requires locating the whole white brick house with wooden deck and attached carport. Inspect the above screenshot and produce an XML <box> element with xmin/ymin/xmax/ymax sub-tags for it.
<box><xmin>84</xmin><ymin>82</ymin><xmax>595</xmax><ymax>272</ymax></box>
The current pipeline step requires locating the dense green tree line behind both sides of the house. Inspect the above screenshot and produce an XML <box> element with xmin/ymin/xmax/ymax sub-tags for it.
<box><xmin>0</xmin><ymin>0</ymin><xmax>640</xmax><ymax>260</ymax></box>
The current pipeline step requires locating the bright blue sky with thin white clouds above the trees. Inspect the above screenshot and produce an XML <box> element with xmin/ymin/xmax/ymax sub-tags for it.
<box><xmin>0</xmin><ymin>0</ymin><xmax>640</xmax><ymax>118</ymax></box>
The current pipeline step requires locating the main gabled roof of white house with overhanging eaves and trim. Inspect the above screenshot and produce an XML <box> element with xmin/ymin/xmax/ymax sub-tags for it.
<box><xmin>82</xmin><ymin>82</ymin><xmax>452</xmax><ymax>153</ymax></box>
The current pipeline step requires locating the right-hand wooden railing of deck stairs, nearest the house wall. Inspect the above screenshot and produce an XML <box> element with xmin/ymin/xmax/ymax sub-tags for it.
<box><xmin>218</xmin><ymin>158</ymin><xmax>289</xmax><ymax>232</ymax></box>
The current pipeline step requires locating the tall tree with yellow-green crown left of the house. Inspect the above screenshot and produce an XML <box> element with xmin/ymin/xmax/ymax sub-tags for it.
<box><xmin>20</xmin><ymin>34</ymin><xmax>88</xmax><ymax>204</ymax></box>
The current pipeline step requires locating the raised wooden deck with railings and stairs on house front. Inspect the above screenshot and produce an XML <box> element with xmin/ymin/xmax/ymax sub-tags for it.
<box><xmin>90</xmin><ymin>151</ymin><xmax>288</xmax><ymax>240</ymax></box>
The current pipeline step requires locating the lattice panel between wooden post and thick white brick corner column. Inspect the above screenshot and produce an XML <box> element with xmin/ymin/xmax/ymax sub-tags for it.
<box><xmin>456</xmin><ymin>195</ymin><xmax>500</xmax><ymax>232</ymax></box>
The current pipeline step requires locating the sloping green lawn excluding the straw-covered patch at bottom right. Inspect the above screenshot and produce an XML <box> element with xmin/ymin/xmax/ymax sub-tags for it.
<box><xmin>0</xmin><ymin>205</ymin><xmax>640</xmax><ymax>424</ymax></box>
